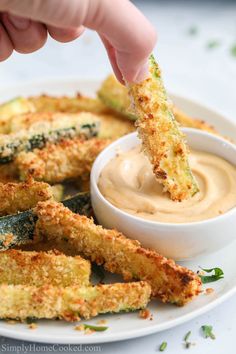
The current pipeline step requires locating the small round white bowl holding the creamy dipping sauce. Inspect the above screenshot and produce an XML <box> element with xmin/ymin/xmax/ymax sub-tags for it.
<box><xmin>90</xmin><ymin>128</ymin><xmax>236</xmax><ymax>260</ymax></box>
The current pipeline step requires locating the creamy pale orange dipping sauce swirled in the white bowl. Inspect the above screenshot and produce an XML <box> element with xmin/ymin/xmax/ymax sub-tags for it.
<box><xmin>98</xmin><ymin>146</ymin><xmax>236</xmax><ymax>223</ymax></box>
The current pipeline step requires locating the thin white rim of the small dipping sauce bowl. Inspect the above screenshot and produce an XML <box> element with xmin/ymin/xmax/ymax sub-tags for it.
<box><xmin>90</xmin><ymin>128</ymin><xmax>236</xmax><ymax>228</ymax></box>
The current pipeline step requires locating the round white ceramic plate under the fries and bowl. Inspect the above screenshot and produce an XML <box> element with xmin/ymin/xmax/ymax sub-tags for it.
<box><xmin>0</xmin><ymin>80</ymin><xmax>236</xmax><ymax>344</ymax></box>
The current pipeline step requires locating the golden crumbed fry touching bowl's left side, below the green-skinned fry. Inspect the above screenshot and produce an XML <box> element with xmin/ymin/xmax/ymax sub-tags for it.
<box><xmin>15</xmin><ymin>138</ymin><xmax>109</xmax><ymax>183</ymax></box>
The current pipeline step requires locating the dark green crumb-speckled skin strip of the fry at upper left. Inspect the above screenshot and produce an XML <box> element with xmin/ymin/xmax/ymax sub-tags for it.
<box><xmin>0</xmin><ymin>122</ymin><xmax>99</xmax><ymax>164</ymax></box>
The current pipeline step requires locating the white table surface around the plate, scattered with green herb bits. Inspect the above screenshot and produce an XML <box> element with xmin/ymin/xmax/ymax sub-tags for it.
<box><xmin>0</xmin><ymin>0</ymin><xmax>236</xmax><ymax>354</ymax></box>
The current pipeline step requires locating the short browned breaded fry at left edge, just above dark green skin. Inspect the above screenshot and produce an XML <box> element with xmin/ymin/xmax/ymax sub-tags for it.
<box><xmin>0</xmin><ymin>179</ymin><xmax>53</xmax><ymax>216</ymax></box>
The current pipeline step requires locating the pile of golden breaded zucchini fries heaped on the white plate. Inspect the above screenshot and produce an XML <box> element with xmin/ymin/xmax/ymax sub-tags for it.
<box><xmin>0</xmin><ymin>57</ymin><xmax>211</xmax><ymax>321</ymax></box>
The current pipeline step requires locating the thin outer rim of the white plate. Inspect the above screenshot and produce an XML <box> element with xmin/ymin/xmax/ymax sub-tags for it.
<box><xmin>0</xmin><ymin>77</ymin><xmax>236</xmax><ymax>344</ymax></box>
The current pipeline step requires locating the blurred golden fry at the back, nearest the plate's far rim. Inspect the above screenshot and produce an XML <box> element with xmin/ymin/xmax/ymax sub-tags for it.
<box><xmin>28</xmin><ymin>94</ymin><xmax>109</xmax><ymax>114</ymax></box>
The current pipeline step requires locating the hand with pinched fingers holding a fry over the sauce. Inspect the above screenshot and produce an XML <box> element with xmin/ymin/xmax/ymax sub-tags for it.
<box><xmin>0</xmin><ymin>0</ymin><xmax>156</xmax><ymax>82</ymax></box>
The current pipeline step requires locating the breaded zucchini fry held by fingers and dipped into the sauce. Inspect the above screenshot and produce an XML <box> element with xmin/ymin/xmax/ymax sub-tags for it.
<box><xmin>129</xmin><ymin>56</ymin><xmax>199</xmax><ymax>201</ymax></box>
